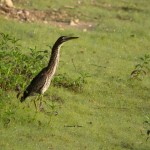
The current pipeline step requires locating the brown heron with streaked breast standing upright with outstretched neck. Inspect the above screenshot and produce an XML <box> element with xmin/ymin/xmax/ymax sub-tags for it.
<box><xmin>20</xmin><ymin>36</ymin><xmax>78</xmax><ymax>110</ymax></box>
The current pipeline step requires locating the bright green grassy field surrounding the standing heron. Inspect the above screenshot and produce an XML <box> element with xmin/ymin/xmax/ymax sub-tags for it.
<box><xmin>0</xmin><ymin>0</ymin><xmax>150</xmax><ymax>150</ymax></box>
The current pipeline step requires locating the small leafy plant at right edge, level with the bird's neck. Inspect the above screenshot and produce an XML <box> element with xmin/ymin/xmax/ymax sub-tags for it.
<box><xmin>130</xmin><ymin>54</ymin><xmax>150</xmax><ymax>80</ymax></box>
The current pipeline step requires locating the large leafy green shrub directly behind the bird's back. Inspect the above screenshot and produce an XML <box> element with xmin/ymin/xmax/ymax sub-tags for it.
<box><xmin>0</xmin><ymin>33</ymin><xmax>48</xmax><ymax>90</ymax></box>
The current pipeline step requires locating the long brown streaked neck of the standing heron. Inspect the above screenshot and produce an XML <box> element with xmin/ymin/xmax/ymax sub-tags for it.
<box><xmin>47</xmin><ymin>45</ymin><xmax>61</xmax><ymax>73</ymax></box>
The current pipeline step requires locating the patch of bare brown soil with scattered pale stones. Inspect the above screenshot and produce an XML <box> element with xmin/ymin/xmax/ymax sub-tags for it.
<box><xmin>0</xmin><ymin>4</ymin><xmax>95</xmax><ymax>31</ymax></box>
